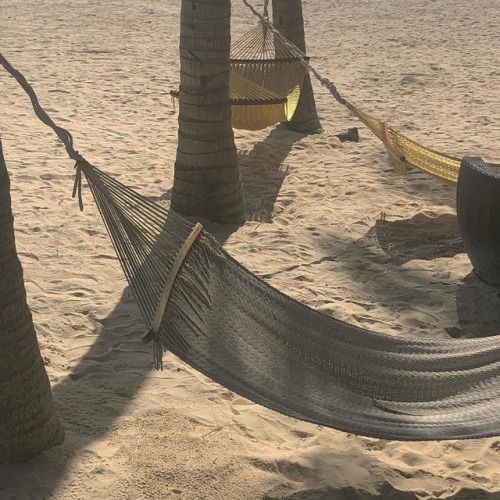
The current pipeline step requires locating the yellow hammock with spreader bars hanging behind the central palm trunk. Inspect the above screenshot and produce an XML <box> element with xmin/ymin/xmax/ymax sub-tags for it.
<box><xmin>170</xmin><ymin>23</ymin><xmax>307</xmax><ymax>130</ymax></box>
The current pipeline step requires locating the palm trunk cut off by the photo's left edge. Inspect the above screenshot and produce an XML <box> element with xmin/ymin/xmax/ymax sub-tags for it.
<box><xmin>0</xmin><ymin>138</ymin><xmax>64</xmax><ymax>463</ymax></box>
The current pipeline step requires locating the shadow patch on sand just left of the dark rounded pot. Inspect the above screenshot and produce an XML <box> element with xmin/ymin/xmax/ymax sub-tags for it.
<box><xmin>292</xmin><ymin>213</ymin><xmax>462</xmax><ymax>321</ymax></box>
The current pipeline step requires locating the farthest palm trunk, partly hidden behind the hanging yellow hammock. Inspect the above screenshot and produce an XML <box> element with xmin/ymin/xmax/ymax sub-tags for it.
<box><xmin>273</xmin><ymin>0</ymin><xmax>322</xmax><ymax>134</ymax></box>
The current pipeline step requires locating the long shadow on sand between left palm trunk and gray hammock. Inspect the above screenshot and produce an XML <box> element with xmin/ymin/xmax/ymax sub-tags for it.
<box><xmin>0</xmin><ymin>288</ymin><xmax>152</xmax><ymax>499</ymax></box>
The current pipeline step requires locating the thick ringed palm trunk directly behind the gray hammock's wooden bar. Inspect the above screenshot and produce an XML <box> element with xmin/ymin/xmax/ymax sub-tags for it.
<box><xmin>172</xmin><ymin>0</ymin><xmax>245</xmax><ymax>224</ymax></box>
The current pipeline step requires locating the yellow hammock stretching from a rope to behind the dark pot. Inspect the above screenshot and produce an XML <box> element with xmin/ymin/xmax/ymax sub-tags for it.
<box><xmin>349</xmin><ymin>105</ymin><xmax>500</xmax><ymax>184</ymax></box>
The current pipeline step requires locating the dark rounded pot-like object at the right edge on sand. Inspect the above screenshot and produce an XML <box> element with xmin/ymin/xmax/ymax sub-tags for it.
<box><xmin>457</xmin><ymin>156</ymin><xmax>500</xmax><ymax>288</ymax></box>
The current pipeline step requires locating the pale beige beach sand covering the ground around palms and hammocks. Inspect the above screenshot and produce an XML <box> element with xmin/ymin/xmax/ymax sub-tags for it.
<box><xmin>0</xmin><ymin>0</ymin><xmax>500</xmax><ymax>500</ymax></box>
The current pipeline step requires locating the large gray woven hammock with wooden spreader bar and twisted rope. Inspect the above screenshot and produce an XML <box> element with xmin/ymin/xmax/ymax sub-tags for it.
<box><xmin>0</xmin><ymin>55</ymin><xmax>500</xmax><ymax>440</ymax></box>
